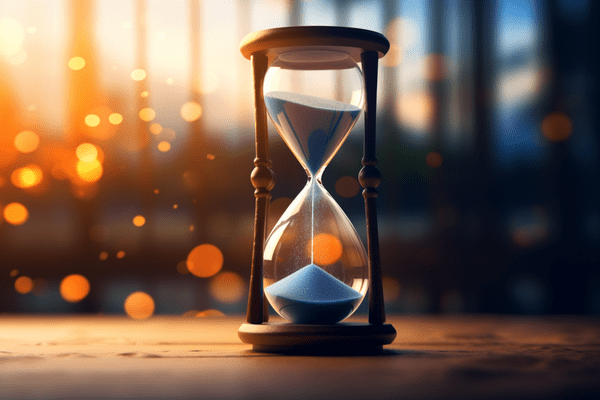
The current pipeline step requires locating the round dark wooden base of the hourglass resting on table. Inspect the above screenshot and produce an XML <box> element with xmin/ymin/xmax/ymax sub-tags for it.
<box><xmin>238</xmin><ymin>322</ymin><xmax>396</xmax><ymax>355</ymax></box>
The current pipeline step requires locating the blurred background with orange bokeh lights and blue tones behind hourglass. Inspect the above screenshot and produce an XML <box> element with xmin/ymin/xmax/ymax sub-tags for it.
<box><xmin>0</xmin><ymin>0</ymin><xmax>600</xmax><ymax>318</ymax></box>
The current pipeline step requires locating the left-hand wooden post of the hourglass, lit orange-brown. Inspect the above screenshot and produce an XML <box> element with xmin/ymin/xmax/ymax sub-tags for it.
<box><xmin>246</xmin><ymin>53</ymin><xmax>275</xmax><ymax>324</ymax></box>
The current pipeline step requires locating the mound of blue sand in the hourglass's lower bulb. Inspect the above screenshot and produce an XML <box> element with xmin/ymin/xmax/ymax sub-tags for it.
<box><xmin>265</xmin><ymin>264</ymin><xmax>363</xmax><ymax>324</ymax></box>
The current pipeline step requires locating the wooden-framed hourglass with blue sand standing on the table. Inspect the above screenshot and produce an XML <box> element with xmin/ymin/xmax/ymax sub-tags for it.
<box><xmin>238</xmin><ymin>26</ymin><xmax>396</xmax><ymax>353</ymax></box>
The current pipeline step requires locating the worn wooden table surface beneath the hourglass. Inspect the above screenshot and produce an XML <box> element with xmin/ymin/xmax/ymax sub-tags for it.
<box><xmin>0</xmin><ymin>315</ymin><xmax>600</xmax><ymax>399</ymax></box>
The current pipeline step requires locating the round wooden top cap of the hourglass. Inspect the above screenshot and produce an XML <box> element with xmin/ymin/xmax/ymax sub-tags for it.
<box><xmin>240</xmin><ymin>26</ymin><xmax>390</xmax><ymax>64</ymax></box>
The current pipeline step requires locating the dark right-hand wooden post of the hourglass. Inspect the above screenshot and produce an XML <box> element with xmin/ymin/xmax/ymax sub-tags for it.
<box><xmin>358</xmin><ymin>51</ymin><xmax>385</xmax><ymax>325</ymax></box>
